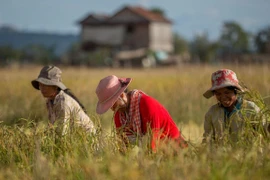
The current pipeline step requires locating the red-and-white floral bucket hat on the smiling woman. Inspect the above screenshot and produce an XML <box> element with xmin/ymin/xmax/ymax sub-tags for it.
<box><xmin>203</xmin><ymin>69</ymin><xmax>243</xmax><ymax>99</ymax></box>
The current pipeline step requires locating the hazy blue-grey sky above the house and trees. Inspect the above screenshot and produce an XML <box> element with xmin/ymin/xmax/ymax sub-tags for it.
<box><xmin>0</xmin><ymin>0</ymin><xmax>270</xmax><ymax>40</ymax></box>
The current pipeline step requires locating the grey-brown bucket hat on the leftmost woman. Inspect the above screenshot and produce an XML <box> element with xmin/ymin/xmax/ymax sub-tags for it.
<box><xmin>31</xmin><ymin>66</ymin><xmax>67</xmax><ymax>90</ymax></box>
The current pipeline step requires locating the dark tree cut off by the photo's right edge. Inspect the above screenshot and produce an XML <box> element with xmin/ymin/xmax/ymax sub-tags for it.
<box><xmin>254</xmin><ymin>26</ymin><xmax>270</xmax><ymax>53</ymax></box>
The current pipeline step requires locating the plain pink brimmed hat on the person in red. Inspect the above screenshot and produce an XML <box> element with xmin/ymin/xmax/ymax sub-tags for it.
<box><xmin>96</xmin><ymin>75</ymin><xmax>132</xmax><ymax>114</ymax></box>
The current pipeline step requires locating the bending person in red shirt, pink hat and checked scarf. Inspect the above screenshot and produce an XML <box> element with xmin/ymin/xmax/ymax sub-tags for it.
<box><xmin>96</xmin><ymin>75</ymin><xmax>188</xmax><ymax>151</ymax></box>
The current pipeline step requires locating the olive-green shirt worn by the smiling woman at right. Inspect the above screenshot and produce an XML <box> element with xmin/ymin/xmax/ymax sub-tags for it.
<box><xmin>202</xmin><ymin>99</ymin><xmax>260</xmax><ymax>143</ymax></box>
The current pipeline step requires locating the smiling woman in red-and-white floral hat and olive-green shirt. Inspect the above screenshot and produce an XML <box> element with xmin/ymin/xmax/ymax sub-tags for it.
<box><xmin>203</xmin><ymin>69</ymin><xmax>266</xmax><ymax>143</ymax></box>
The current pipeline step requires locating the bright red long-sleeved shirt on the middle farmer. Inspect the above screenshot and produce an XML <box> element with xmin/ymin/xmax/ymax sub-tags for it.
<box><xmin>114</xmin><ymin>94</ymin><xmax>187</xmax><ymax>150</ymax></box>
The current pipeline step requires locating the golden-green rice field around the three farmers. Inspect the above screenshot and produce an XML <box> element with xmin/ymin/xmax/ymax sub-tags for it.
<box><xmin>0</xmin><ymin>64</ymin><xmax>270</xmax><ymax>180</ymax></box>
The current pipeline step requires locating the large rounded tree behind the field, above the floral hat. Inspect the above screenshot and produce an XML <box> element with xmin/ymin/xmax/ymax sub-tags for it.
<box><xmin>219</xmin><ymin>21</ymin><xmax>249</xmax><ymax>54</ymax></box>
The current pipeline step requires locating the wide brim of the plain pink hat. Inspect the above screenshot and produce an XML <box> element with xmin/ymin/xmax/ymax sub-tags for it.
<box><xmin>96</xmin><ymin>78</ymin><xmax>132</xmax><ymax>114</ymax></box>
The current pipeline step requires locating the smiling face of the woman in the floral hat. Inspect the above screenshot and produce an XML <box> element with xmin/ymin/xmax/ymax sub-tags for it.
<box><xmin>214</xmin><ymin>87</ymin><xmax>237</xmax><ymax>109</ymax></box>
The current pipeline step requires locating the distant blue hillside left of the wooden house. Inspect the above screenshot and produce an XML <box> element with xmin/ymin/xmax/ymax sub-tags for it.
<box><xmin>0</xmin><ymin>27</ymin><xmax>79</xmax><ymax>56</ymax></box>
